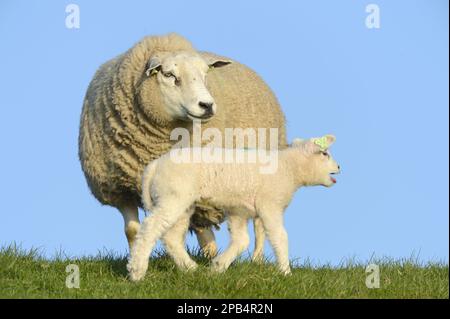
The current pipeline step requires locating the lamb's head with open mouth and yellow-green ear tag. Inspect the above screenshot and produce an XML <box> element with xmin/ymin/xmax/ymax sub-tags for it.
<box><xmin>292</xmin><ymin>135</ymin><xmax>340</xmax><ymax>187</ymax></box>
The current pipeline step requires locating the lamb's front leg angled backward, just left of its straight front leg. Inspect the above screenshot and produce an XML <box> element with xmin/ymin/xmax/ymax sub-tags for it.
<box><xmin>212</xmin><ymin>215</ymin><xmax>250</xmax><ymax>272</ymax></box>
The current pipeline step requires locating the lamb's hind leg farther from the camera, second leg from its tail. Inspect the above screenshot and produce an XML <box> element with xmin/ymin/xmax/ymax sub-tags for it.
<box><xmin>163</xmin><ymin>212</ymin><xmax>197</xmax><ymax>270</ymax></box>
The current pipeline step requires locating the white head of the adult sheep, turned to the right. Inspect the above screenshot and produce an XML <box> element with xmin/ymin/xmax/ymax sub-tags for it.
<box><xmin>145</xmin><ymin>51</ymin><xmax>231</xmax><ymax>122</ymax></box>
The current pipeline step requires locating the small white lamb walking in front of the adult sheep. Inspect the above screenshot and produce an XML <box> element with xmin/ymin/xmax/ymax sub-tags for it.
<box><xmin>127</xmin><ymin>135</ymin><xmax>340</xmax><ymax>281</ymax></box>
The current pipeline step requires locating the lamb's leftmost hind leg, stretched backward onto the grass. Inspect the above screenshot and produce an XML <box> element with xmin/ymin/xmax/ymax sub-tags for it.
<box><xmin>127</xmin><ymin>198</ymin><xmax>191</xmax><ymax>281</ymax></box>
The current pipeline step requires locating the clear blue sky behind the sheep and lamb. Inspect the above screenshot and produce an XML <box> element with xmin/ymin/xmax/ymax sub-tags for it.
<box><xmin>0</xmin><ymin>0</ymin><xmax>449</xmax><ymax>264</ymax></box>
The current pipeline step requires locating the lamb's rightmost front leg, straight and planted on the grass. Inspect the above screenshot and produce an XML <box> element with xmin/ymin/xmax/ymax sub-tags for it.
<box><xmin>259</xmin><ymin>210</ymin><xmax>291</xmax><ymax>275</ymax></box>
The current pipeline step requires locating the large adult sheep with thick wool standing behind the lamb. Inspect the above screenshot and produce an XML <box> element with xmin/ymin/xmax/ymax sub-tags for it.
<box><xmin>79</xmin><ymin>34</ymin><xmax>286</xmax><ymax>255</ymax></box>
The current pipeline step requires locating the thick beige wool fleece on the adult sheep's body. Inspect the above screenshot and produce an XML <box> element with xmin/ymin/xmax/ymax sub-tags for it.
<box><xmin>79</xmin><ymin>34</ymin><xmax>286</xmax><ymax>230</ymax></box>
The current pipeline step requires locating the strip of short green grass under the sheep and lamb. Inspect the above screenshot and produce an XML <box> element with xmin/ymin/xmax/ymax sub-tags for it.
<box><xmin>0</xmin><ymin>245</ymin><xmax>449</xmax><ymax>298</ymax></box>
